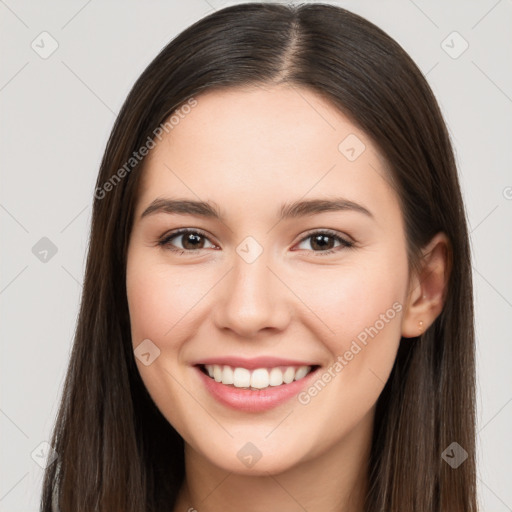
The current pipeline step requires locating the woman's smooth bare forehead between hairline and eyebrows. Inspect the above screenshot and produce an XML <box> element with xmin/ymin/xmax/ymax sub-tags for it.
<box><xmin>135</xmin><ymin>86</ymin><xmax>396</xmax><ymax>223</ymax></box>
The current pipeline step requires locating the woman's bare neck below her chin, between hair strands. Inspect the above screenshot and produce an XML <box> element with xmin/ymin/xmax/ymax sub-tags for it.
<box><xmin>174</xmin><ymin>409</ymin><xmax>374</xmax><ymax>512</ymax></box>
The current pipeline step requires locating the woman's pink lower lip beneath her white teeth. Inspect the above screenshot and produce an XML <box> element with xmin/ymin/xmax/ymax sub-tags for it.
<box><xmin>195</xmin><ymin>366</ymin><xmax>318</xmax><ymax>412</ymax></box>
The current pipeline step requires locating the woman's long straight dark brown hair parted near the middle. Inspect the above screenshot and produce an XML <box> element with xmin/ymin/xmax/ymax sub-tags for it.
<box><xmin>41</xmin><ymin>3</ymin><xmax>477</xmax><ymax>512</ymax></box>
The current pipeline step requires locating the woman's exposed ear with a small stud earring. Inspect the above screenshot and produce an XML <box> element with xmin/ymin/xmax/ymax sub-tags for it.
<box><xmin>402</xmin><ymin>232</ymin><xmax>452</xmax><ymax>338</ymax></box>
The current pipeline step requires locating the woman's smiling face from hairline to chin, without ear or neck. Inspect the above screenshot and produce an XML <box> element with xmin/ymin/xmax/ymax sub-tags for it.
<box><xmin>127</xmin><ymin>86</ymin><xmax>409</xmax><ymax>474</ymax></box>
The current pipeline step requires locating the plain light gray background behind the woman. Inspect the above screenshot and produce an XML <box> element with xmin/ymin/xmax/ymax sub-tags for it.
<box><xmin>0</xmin><ymin>0</ymin><xmax>512</xmax><ymax>512</ymax></box>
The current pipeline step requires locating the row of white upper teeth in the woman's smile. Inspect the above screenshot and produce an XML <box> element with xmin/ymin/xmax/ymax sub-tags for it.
<box><xmin>205</xmin><ymin>364</ymin><xmax>311</xmax><ymax>389</ymax></box>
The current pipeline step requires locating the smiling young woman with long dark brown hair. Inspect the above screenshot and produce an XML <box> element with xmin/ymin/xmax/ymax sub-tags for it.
<box><xmin>41</xmin><ymin>3</ymin><xmax>477</xmax><ymax>512</ymax></box>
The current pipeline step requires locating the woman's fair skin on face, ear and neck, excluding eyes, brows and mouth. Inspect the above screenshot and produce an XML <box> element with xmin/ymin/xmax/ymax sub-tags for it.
<box><xmin>127</xmin><ymin>85</ymin><xmax>448</xmax><ymax>512</ymax></box>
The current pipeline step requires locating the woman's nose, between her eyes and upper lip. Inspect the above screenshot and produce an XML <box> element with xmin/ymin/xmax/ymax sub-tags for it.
<box><xmin>214</xmin><ymin>252</ymin><xmax>293</xmax><ymax>338</ymax></box>
